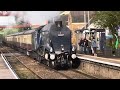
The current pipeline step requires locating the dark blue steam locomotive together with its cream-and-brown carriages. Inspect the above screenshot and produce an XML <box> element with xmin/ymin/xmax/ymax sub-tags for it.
<box><xmin>5</xmin><ymin>21</ymin><xmax>77</xmax><ymax>68</ymax></box>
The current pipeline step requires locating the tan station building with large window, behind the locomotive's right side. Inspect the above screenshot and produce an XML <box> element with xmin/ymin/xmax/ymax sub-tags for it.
<box><xmin>60</xmin><ymin>11</ymin><xmax>95</xmax><ymax>45</ymax></box>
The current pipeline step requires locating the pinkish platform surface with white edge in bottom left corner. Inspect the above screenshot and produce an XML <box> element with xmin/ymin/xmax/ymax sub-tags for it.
<box><xmin>0</xmin><ymin>55</ymin><xmax>17</xmax><ymax>79</ymax></box>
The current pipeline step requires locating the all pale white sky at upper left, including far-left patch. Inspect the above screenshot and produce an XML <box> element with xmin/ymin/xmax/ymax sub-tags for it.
<box><xmin>0</xmin><ymin>11</ymin><xmax>59</xmax><ymax>25</ymax></box>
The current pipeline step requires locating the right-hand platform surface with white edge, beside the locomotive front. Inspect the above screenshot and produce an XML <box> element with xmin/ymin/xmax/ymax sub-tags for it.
<box><xmin>77</xmin><ymin>54</ymin><xmax>120</xmax><ymax>67</ymax></box>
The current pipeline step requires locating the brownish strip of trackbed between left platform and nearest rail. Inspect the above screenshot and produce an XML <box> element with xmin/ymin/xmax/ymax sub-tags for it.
<box><xmin>1</xmin><ymin>47</ymin><xmax>41</xmax><ymax>79</ymax></box>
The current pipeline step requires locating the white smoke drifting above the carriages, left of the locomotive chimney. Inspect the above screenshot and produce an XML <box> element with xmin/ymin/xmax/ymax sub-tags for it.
<box><xmin>11</xmin><ymin>11</ymin><xmax>60</xmax><ymax>25</ymax></box>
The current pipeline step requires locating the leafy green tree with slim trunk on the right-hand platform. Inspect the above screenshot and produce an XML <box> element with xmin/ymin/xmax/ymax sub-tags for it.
<box><xmin>93</xmin><ymin>11</ymin><xmax>120</xmax><ymax>48</ymax></box>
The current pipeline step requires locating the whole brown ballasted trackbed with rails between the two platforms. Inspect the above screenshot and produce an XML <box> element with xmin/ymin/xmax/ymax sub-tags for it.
<box><xmin>0</xmin><ymin>47</ymin><xmax>96</xmax><ymax>79</ymax></box>
